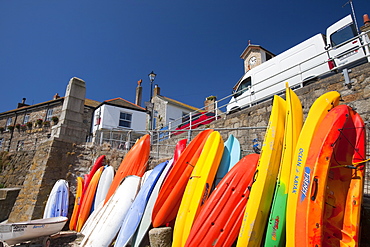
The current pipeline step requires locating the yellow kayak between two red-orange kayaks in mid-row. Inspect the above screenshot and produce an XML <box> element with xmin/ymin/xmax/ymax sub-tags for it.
<box><xmin>172</xmin><ymin>131</ymin><xmax>224</xmax><ymax>247</ymax></box>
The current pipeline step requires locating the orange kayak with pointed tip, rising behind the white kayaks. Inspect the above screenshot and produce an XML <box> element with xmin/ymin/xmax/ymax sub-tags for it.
<box><xmin>104</xmin><ymin>134</ymin><xmax>150</xmax><ymax>203</ymax></box>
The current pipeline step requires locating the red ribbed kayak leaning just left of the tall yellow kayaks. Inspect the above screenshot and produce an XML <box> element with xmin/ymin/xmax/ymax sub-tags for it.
<box><xmin>185</xmin><ymin>154</ymin><xmax>259</xmax><ymax>247</ymax></box>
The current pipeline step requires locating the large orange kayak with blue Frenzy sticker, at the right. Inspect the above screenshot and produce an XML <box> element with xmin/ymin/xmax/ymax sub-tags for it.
<box><xmin>295</xmin><ymin>105</ymin><xmax>365</xmax><ymax>246</ymax></box>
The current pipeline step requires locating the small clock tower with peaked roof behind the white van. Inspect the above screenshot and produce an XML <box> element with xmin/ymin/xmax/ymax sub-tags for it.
<box><xmin>240</xmin><ymin>40</ymin><xmax>275</xmax><ymax>72</ymax></box>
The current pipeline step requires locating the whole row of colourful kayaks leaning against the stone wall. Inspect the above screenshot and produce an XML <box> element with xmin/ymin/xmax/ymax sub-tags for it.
<box><xmin>4</xmin><ymin>86</ymin><xmax>366</xmax><ymax>247</ymax></box>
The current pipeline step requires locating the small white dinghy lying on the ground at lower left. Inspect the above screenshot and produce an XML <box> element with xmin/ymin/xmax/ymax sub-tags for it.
<box><xmin>0</xmin><ymin>216</ymin><xmax>68</xmax><ymax>245</ymax></box>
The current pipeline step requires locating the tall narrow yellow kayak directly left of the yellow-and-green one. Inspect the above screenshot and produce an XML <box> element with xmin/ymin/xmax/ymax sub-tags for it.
<box><xmin>237</xmin><ymin>95</ymin><xmax>286</xmax><ymax>247</ymax></box>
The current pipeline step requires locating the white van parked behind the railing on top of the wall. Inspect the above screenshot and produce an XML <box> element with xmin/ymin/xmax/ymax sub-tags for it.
<box><xmin>226</xmin><ymin>15</ymin><xmax>370</xmax><ymax>113</ymax></box>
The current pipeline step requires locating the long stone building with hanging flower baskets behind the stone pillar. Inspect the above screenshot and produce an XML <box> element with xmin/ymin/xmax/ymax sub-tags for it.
<box><xmin>0</xmin><ymin>78</ymin><xmax>100</xmax><ymax>151</ymax></box>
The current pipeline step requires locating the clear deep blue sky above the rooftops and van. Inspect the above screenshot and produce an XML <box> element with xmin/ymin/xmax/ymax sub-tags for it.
<box><xmin>0</xmin><ymin>0</ymin><xmax>370</xmax><ymax>112</ymax></box>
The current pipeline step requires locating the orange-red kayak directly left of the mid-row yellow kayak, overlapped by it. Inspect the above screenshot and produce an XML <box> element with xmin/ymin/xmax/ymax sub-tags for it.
<box><xmin>152</xmin><ymin>129</ymin><xmax>213</xmax><ymax>227</ymax></box>
